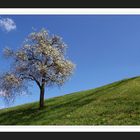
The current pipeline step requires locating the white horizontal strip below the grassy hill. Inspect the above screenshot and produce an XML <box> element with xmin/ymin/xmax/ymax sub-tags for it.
<box><xmin>0</xmin><ymin>126</ymin><xmax>140</xmax><ymax>132</ymax></box>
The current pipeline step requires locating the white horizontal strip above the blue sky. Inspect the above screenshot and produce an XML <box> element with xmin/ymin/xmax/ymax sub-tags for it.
<box><xmin>0</xmin><ymin>8</ymin><xmax>140</xmax><ymax>15</ymax></box>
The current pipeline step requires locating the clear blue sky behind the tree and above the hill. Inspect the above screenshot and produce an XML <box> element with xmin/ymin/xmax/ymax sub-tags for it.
<box><xmin>0</xmin><ymin>15</ymin><xmax>140</xmax><ymax>107</ymax></box>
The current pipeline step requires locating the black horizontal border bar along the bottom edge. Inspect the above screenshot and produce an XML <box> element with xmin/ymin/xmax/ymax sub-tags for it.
<box><xmin>0</xmin><ymin>132</ymin><xmax>140</xmax><ymax>140</ymax></box>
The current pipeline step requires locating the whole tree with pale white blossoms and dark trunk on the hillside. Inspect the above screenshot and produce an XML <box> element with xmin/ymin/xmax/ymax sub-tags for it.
<box><xmin>0</xmin><ymin>29</ymin><xmax>75</xmax><ymax>109</ymax></box>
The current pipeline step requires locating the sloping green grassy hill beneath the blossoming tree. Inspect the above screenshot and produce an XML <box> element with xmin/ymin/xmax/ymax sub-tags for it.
<box><xmin>0</xmin><ymin>77</ymin><xmax>140</xmax><ymax>125</ymax></box>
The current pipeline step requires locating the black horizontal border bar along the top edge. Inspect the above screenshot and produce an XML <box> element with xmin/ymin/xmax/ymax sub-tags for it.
<box><xmin>0</xmin><ymin>0</ymin><xmax>140</xmax><ymax>8</ymax></box>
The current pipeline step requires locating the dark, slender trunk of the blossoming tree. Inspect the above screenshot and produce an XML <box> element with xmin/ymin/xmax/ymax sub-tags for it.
<box><xmin>39</xmin><ymin>85</ymin><xmax>45</xmax><ymax>109</ymax></box>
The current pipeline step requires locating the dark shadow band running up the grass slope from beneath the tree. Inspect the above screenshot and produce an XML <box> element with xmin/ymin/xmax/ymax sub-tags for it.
<box><xmin>0</xmin><ymin>78</ymin><xmax>137</xmax><ymax>125</ymax></box>
